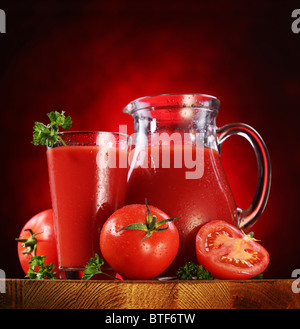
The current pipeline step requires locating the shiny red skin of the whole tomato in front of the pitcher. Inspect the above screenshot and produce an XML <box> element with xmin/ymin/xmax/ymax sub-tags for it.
<box><xmin>100</xmin><ymin>204</ymin><xmax>180</xmax><ymax>280</ymax></box>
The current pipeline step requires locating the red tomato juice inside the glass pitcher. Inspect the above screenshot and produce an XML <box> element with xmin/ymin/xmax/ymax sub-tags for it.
<box><xmin>126</xmin><ymin>146</ymin><xmax>237</xmax><ymax>276</ymax></box>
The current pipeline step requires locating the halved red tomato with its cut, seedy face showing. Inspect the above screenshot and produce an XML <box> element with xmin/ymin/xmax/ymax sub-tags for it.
<box><xmin>196</xmin><ymin>220</ymin><xmax>269</xmax><ymax>280</ymax></box>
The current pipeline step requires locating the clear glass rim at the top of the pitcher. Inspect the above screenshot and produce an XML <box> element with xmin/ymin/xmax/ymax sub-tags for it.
<box><xmin>123</xmin><ymin>93</ymin><xmax>221</xmax><ymax>114</ymax></box>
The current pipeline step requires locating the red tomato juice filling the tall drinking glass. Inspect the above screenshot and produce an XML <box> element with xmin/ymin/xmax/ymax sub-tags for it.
<box><xmin>47</xmin><ymin>146</ymin><xmax>128</xmax><ymax>269</ymax></box>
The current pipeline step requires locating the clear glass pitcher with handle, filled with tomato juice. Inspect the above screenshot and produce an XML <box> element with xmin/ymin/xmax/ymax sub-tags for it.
<box><xmin>123</xmin><ymin>94</ymin><xmax>271</xmax><ymax>276</ymax></box>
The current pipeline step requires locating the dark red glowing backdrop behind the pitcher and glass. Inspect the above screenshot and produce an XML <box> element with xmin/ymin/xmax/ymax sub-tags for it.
<box><xmin>0</xmin><ymin>0</ymin><xmax>300</xmax><ymax>278</ymax></box>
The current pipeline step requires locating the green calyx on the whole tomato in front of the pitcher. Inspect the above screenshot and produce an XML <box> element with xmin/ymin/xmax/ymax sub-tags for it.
<box><xmin>117</xmin><ymin>199</ymin><xmax>180</xmax><ymax>243</ymax></box>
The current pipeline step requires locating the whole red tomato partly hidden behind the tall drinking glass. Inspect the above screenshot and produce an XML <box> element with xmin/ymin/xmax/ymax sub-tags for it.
<box><xmin>16</xmin><ymin>209</ymin><xmax>58</xmax><ymax>277</ymax></box>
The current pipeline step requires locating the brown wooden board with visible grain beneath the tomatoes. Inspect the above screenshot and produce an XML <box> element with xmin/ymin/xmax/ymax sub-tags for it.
<box><xmin>0</xmin><ymin>279</ymin><xmax>300</xmax><ymax>309</ymax></box>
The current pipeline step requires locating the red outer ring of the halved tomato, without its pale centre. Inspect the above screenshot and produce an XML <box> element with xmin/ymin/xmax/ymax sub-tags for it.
<box><xmin>196</xmin><ymin>220</ymin><xmax>269</xmax><ymax>280</ymax></box>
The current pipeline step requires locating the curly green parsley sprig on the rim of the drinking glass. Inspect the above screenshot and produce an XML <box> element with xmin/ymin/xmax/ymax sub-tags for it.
<box><xmin>32</xmin><ymin>111</ymin><xmax>72</xmax><ymax>147</ymax></box>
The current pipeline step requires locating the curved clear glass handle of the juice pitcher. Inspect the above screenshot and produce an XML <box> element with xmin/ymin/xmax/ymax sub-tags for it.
<box><xmin>217</xmin><ymin>123</ymin><xmax>271</xmax><ymax>229</ymax></box>
